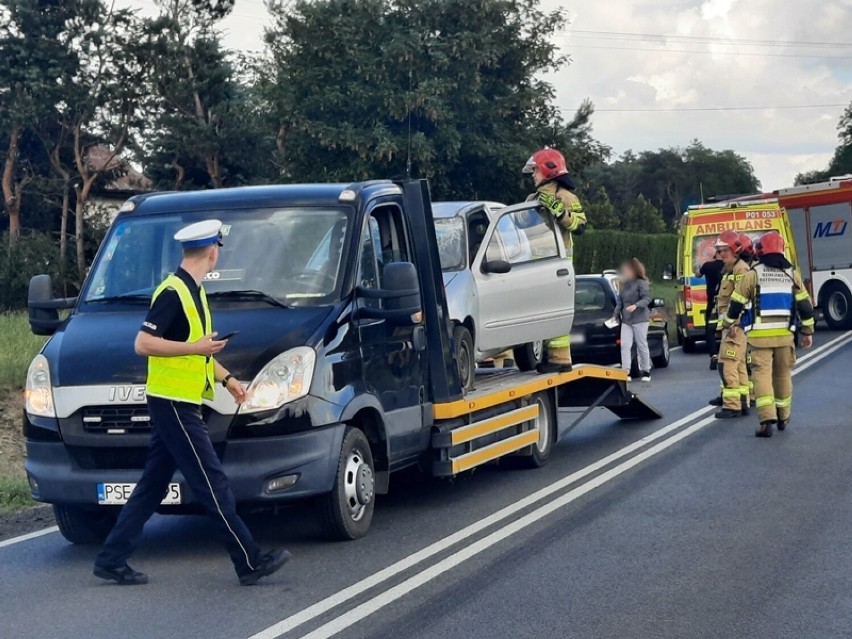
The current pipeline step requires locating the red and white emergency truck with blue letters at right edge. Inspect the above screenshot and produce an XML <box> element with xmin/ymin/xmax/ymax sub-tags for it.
<box><xmin>778</xmin><ymin>175</ymin><xmax>852</xmax><ymax>330</ymax></box>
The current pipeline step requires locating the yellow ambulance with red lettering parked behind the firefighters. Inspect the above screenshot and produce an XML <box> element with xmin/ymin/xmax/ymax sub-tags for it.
<box><xmin>676</xmin><ymin>195</ymin><xmax>796</xmax><ymax>353</ymax></box>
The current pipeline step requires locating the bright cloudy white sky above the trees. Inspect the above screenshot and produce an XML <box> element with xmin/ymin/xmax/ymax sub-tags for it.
<box><xmin>119</xmin><ymin>0</ymin><xmax>852</xmax><ymax>190</ymax></box>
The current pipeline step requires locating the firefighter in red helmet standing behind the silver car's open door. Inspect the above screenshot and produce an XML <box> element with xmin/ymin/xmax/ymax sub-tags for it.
<box><xmin>523</xmin><ymin>147</ymin><xmax>586</xmax><ymax>373</ymax></box>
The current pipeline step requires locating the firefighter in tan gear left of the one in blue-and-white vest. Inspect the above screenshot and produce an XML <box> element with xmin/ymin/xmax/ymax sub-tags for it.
<box><xmin>714</xmin><ymin>231</ymin><xmax>749</xmax><ymax>419</ymax></box>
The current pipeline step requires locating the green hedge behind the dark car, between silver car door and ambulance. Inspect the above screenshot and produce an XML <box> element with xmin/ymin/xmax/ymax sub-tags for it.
<box><xmin>574</xmin><ymin>230</ymin><xmax>677</xmax><ymax>280</ymax></box>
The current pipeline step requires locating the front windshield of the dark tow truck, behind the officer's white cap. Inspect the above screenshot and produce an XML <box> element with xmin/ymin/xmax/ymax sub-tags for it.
<box><xmin>83</xmin><ymin>208</ymin><xmax>349</xmax><ymax>306</ymax></box>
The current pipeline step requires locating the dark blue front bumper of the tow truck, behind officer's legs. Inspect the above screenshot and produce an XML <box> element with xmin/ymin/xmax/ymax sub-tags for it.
<box><xmin>25</xmin><ymin>424</ymin><xmax>345</xmax><ymax>504</ymax></box>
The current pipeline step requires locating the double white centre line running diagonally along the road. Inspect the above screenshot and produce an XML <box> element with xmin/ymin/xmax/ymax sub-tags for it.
<box><xmin>249</xmin><ymin>332</ymin><xmax>852</xmax><ymax>639</ymax></box>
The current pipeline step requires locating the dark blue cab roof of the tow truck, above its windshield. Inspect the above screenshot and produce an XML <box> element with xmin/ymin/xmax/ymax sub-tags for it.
<box><xmin>115</xmin><ymin>180</ymin><xmax>401</xmax><ymax>217</ymax></box>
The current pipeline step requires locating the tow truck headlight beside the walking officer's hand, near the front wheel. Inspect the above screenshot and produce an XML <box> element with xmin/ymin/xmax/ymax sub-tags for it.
<box><xmin>240</xmin><ymin>346</ymin><xmax>316</xmax><ymax>413</ymax></box>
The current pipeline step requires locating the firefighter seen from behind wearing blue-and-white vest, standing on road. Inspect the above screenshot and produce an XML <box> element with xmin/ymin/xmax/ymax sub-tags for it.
<box><xmin>722</xmin><ymin>231</ymin><xmax>814</xmax><ymax>437</ymax></box>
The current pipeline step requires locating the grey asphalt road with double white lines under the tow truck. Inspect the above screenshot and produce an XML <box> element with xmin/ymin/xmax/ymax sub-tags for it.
<box><xmin>0</xmin><ymin>331</ymin><xmax>852</xmax><ymax>639</ymax></box>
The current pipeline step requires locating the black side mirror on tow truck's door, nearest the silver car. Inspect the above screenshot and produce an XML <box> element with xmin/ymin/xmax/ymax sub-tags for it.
<box><xmin>356</xmin><ymin>262</ymin><xmax>423</xmax><ymax>324</ymax></box>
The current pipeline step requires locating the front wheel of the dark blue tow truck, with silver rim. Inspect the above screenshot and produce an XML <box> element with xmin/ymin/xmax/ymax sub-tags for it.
<box><xmin>319</xmin><ymin>426</ymin><xmax>376</xmax><ymax>541</ymax></box>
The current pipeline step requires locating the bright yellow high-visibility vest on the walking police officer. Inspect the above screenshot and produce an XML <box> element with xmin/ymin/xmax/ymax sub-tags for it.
<box><xmin>145</xmin><ymin>275</ymin><xmax>214</xmax><ymax>404</ymax></box>
